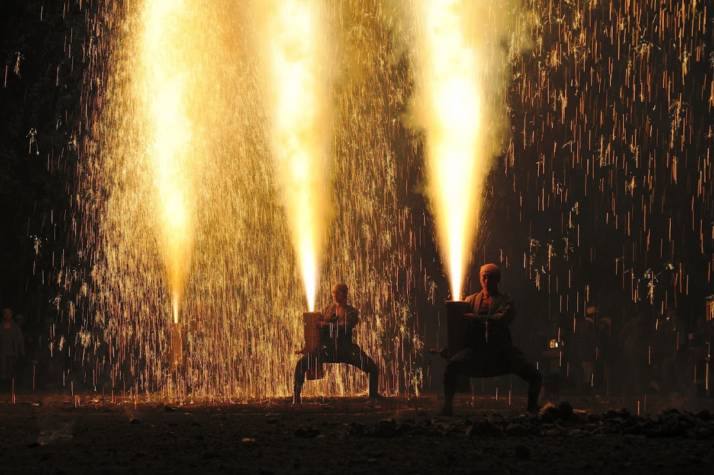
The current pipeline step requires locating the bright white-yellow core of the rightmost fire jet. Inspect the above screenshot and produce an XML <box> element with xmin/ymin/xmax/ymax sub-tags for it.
<box><xmin>417</xmin><ymin>0</ymin><xmax>488</xmax><ymax>300</ymax></box>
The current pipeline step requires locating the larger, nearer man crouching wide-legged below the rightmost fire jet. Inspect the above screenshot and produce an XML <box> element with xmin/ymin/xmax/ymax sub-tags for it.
<box><xmin>442</xmin><ymin>264</ymin><xmax>542</xmax><ymax>415</ymax></box>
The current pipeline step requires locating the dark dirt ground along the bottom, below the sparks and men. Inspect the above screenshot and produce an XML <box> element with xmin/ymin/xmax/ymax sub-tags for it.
<box><xmin>0</xmin><ymin>396</ymin><xmax>714</xmax><ymax>474</ymax></box>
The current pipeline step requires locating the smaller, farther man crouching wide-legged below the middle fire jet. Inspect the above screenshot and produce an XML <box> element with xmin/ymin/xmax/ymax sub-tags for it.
<box><xmin>293</xmin><ymin>284</ymin><xmax>380</xmax><ymax>404</ymax></box>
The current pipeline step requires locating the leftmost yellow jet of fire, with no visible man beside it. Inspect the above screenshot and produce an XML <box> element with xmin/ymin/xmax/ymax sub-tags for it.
<box><xmin>137</xmin><ymin>0</ymin><xmax>196</xmax><ymax>323</ymax></box>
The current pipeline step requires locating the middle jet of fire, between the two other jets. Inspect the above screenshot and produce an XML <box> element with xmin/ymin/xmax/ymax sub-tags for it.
<box><xmin>257</xmin><ymin>0</ymin><xmax>331</xmax><ymax>311</ymax></box>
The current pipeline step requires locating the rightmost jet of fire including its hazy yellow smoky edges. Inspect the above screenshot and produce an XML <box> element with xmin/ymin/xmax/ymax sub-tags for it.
<box><xmin>412</xmin><ymin>0</ymin><xmax>520</xmax><ymax>300</ymax></box>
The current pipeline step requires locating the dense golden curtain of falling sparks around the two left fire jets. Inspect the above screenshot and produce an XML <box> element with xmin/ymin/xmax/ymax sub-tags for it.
<box><xmin>71</xmin><ymin>0</ymin><xmax>421</xmax><ymax>400</ymax></box>
